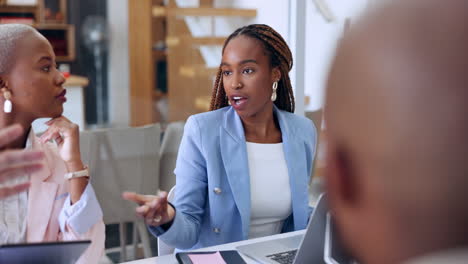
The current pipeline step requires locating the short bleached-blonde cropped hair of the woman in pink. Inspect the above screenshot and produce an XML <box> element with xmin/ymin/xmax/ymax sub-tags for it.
<box><xmin>0</xmin><ymin>24</ymin><xmax>37</xmax><ymax>74</ymax></box>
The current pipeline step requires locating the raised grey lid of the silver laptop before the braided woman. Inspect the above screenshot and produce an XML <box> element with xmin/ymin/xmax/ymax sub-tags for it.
<box><xmin>294</xmin><ymin>193</ymin><xmax>328</xmax><ymax>263</ymax></box>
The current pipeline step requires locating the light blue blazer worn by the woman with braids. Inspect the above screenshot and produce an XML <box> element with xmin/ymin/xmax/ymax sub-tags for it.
<box><xmin>149</xmin><ymin>106</ymin><xmax>317</xmax><ymax>249</ymax></box>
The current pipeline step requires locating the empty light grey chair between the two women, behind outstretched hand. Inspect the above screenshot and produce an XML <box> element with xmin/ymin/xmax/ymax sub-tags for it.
<box><xmin>80</xmin><ymin>124</ymin><xmax>161</xmax><ymax>261</ymax></box>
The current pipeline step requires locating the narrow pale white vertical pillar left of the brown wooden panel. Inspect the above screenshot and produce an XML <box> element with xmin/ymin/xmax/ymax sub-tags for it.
<box><xmin>107</xmin><ymin>0</ymin><xmax>130</xmax><ymax>126</ymax></box>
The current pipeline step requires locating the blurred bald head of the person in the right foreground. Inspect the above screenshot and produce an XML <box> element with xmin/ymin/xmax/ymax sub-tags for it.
<box><xmin>326</xmin><ymin>0</ymin><xmax>468</xmax><ymax>263</ymax></box>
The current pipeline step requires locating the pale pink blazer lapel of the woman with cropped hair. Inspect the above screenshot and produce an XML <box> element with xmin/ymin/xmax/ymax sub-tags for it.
<box><xmin>27</xmin><ymin>135</ymin><xmax>58</xmax><ymax>242</ymax></box>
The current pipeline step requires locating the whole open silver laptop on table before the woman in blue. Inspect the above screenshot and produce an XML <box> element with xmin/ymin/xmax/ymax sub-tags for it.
<box><xmin>236</xmin><ymin>194</ymin><xmax>328</xmax><ymax>264</ymax></box>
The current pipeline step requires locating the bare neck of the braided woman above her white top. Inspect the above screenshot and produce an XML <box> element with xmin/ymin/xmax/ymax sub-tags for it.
<box><xmin>241</xmin><ymin>110</ymin><xmax>281</xmax><ymax>143</ymax></box>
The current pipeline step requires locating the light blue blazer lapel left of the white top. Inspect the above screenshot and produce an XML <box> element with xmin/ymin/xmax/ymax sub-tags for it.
<box><xmin>219</xmin><ymin>108</ymin><xmax>250</xmax><ymax>238</ymax></box>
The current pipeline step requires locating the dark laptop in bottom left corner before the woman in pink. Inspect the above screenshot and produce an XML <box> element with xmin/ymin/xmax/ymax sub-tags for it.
<box><xmin>0</xmin><ymin>240</ymin><xmax>91</xmax><ymax>264</ymax></box>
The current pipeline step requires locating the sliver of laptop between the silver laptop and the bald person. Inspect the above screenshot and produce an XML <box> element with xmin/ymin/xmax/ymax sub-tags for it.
<box><xmin>323</xmin><ymin>213</ymin><xmax>357</xmax><ymax>264</ymax></box>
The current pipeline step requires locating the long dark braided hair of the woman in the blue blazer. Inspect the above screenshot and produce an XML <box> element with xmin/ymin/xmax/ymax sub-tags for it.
<box><xmin>210</xmin><ymin>24</ymin><xmax>295</xmax><ymax>113</ymax></box>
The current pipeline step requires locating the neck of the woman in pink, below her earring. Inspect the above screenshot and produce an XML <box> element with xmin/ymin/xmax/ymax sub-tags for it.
<box><xmin>0</xmin><ymin>113</ymin><xmax>34</xmax><ymax>149</ymax></box>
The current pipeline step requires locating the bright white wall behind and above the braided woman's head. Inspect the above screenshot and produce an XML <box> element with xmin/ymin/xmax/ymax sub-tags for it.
<box><xmin>211</xmin><ymin>0</ymin><xmax>370</xmax><ymax>111</ymax></box>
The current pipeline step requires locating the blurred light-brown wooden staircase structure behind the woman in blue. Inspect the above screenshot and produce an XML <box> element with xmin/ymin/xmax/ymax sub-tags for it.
<box><xmin>128</xmin><ymin>0</ymin><xmax>257</xmax><ymax>125</ymax></box>
